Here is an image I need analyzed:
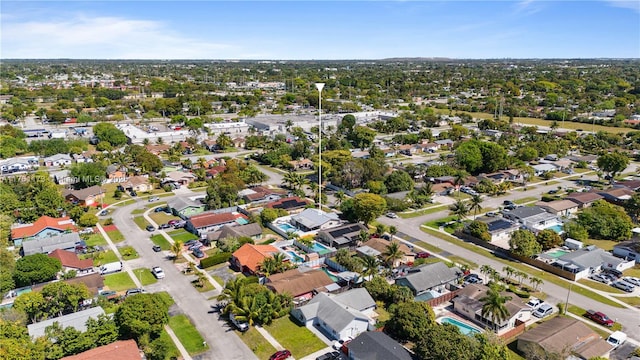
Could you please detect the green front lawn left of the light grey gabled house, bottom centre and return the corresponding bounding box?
[264,316,327,359]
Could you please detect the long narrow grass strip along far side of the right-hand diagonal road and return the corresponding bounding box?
[420,226,623,308]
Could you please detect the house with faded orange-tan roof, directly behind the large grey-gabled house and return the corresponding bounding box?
[265,267,339,301]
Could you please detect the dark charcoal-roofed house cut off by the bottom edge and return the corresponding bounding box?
[346,331,413,360]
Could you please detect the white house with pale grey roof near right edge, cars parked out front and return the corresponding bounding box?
[552,245,635,279]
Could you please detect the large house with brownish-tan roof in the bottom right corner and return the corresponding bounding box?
[517,316,613,360]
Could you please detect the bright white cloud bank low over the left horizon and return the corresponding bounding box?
[1,15,244,59]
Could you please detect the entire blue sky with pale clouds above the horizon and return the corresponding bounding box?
[0,0,640,60]
